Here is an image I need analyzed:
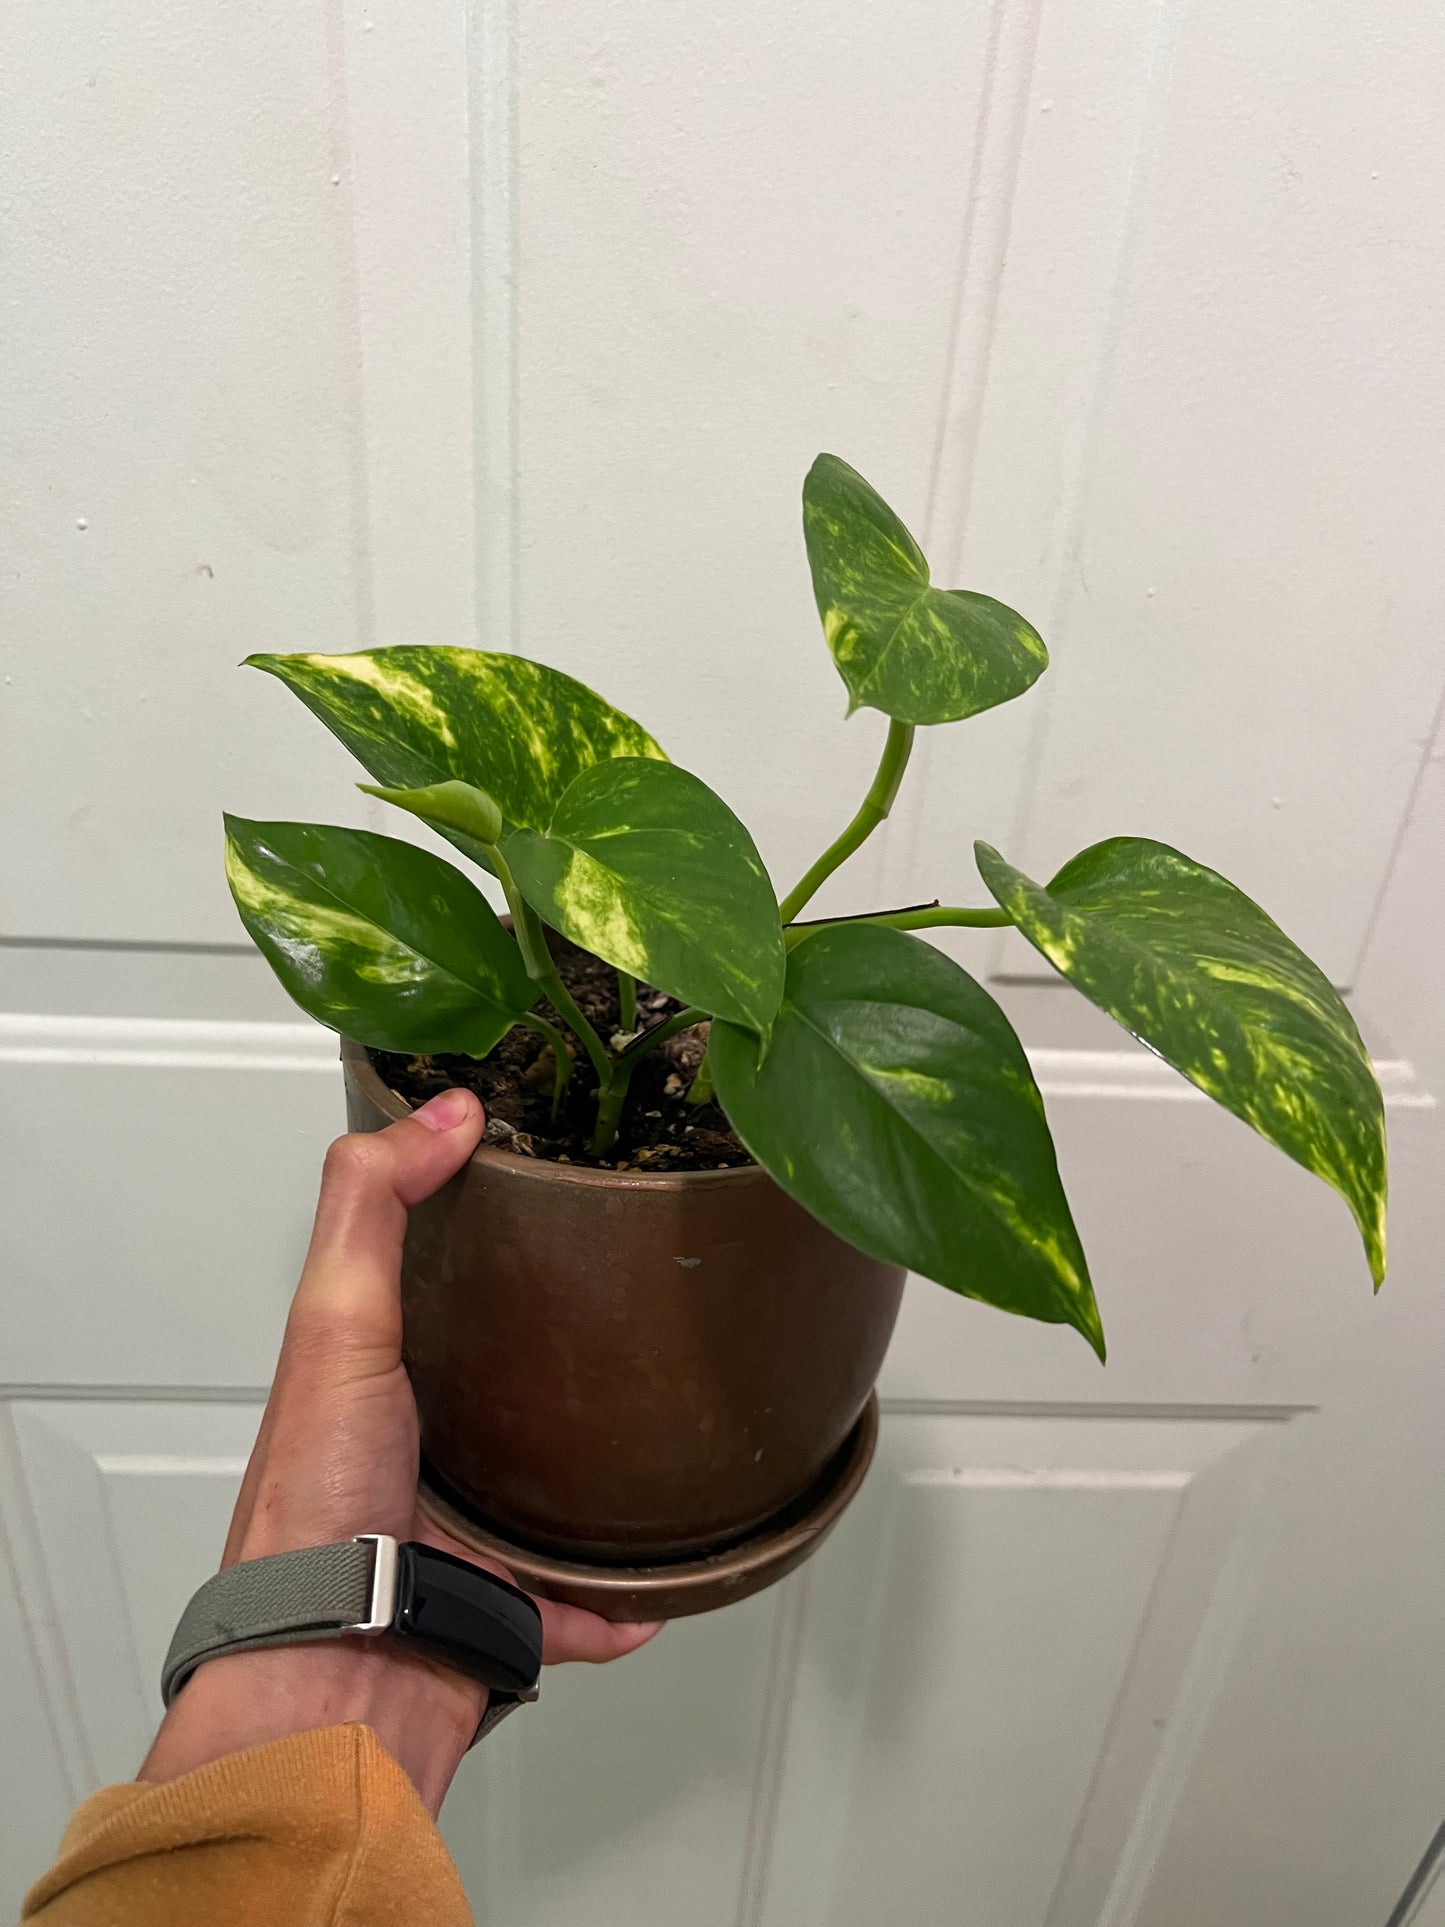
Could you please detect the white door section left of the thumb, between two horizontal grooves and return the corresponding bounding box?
[0,1012,345,1386]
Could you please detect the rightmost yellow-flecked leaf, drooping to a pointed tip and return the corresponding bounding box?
[977,836,1387,1285]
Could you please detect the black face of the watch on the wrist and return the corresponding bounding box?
[393,1545,541,1692]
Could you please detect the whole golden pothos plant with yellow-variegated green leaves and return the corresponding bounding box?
[225,455,1385,1359]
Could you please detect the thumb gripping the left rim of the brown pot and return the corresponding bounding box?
[283,1091,486,1368]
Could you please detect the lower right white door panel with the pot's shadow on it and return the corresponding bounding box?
[761,1414,1279,1927]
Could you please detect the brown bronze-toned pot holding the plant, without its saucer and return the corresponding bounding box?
[341,1039,904,1565]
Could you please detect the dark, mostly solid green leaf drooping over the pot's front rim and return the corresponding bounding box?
[711,923,1104,1359]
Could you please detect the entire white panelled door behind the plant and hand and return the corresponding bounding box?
[0,0,1445,1927]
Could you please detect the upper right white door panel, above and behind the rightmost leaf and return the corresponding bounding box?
[965,0,1445,983]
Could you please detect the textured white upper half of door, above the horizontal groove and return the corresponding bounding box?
[2,0,1445,963]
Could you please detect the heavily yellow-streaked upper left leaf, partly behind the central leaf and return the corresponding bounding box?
[247,644,663,856]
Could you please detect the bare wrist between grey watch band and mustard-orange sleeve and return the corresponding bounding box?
[139,1636,487,1815]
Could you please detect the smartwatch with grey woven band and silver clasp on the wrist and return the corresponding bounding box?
[160,1532,541,1746]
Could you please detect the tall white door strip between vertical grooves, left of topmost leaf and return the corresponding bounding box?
[516,0,1025,906]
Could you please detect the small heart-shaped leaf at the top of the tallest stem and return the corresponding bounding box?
[803,455,1048,723]
